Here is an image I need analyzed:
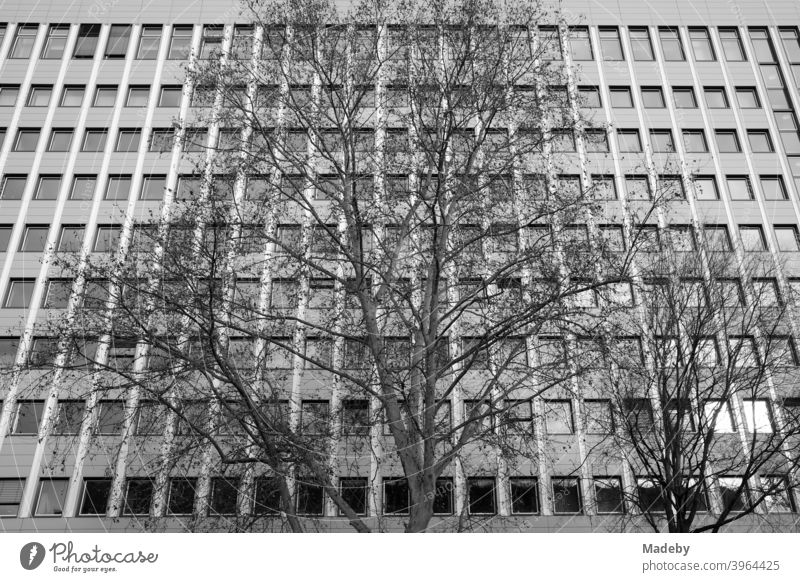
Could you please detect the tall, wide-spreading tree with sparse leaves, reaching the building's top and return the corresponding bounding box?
[36,0,648,531]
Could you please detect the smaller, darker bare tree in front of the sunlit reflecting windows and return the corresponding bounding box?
[587,231,800,532]
